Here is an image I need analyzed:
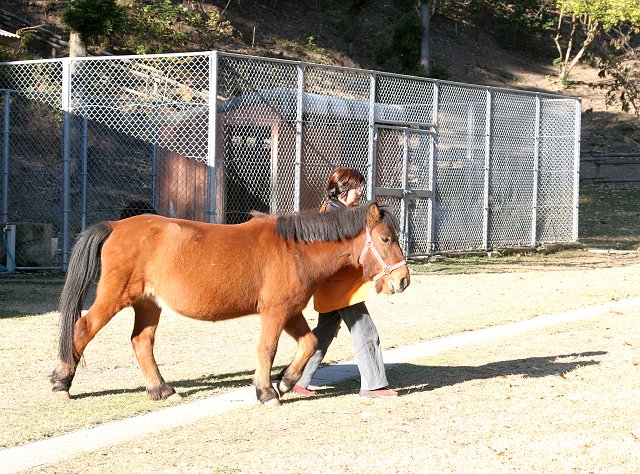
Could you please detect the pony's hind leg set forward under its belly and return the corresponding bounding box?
[131,300,176,400]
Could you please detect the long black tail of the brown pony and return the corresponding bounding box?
[58,222,113,364]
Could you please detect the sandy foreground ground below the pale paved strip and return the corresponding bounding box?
[23,266,640,473]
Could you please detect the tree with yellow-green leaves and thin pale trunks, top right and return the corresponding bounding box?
[554,0,640,81]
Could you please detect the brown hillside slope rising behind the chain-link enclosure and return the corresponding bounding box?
[2,0,640,155]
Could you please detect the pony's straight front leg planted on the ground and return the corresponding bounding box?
[253,312,283,405]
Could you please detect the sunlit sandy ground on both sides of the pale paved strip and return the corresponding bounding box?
[0,252,640,472]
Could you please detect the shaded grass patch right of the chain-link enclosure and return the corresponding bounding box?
[578,183,640,250]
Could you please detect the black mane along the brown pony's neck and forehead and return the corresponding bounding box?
[276,203,398,243]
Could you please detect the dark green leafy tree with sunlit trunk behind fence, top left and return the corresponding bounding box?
[62,0,121,56]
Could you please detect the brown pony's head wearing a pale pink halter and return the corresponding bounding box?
[358,202,411,294]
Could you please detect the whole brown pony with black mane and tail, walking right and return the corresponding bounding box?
[51,202,409,404]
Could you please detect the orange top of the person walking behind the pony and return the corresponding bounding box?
[313,199,371,313]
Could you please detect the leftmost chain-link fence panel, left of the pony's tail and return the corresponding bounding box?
[0,61,63,269]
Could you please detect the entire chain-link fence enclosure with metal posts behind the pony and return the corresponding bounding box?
[0,51,580,269]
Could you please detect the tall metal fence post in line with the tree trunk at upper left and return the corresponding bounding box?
[62,58,71,272]
